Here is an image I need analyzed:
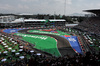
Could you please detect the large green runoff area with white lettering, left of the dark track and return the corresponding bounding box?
[15,33,61,57]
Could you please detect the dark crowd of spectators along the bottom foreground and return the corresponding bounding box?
[0,52,100,66]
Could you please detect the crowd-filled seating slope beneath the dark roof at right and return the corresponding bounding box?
[75,17,100,34]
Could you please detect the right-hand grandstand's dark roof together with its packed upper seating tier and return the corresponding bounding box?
[74,10,100,36]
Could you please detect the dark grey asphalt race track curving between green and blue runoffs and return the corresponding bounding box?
[18,29,76,56]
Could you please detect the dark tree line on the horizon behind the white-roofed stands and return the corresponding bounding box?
[0,14,86,23]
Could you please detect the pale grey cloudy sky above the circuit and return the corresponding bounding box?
[0,0,100,15]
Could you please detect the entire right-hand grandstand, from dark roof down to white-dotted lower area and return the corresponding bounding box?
[73,9,100,55]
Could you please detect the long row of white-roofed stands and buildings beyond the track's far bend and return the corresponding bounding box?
[0,16,66,28]
